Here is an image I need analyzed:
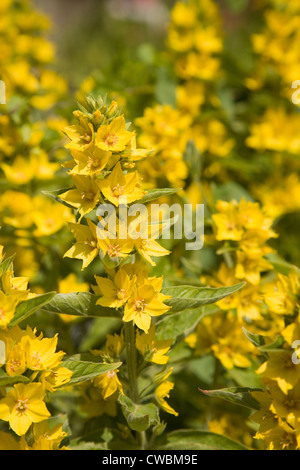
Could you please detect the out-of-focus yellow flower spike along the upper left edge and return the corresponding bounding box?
[0,0,72,276]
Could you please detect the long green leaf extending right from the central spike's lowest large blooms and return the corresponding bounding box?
[162,282,245,313]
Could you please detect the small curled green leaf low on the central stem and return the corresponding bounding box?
[118,394,159,432]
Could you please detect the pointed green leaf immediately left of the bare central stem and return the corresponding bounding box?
[62,354,122,385]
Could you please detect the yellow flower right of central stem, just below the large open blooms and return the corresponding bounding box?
[136,325,173,364]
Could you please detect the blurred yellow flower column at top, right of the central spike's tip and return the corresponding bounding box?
[135,0,234,191]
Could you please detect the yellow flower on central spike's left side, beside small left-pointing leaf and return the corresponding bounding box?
[59,175,100,221]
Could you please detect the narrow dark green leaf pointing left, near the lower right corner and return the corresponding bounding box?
[199,387,262,410]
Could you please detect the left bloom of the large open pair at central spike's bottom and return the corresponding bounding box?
[95,268,135,308]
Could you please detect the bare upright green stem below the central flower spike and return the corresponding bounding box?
[125,321,139,403]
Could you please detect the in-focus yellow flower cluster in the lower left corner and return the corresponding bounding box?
[0,247,72,450]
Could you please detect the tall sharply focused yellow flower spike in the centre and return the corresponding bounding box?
[59,96,176,422]
